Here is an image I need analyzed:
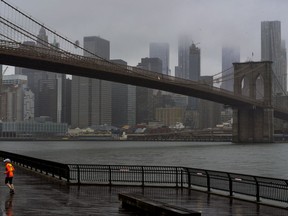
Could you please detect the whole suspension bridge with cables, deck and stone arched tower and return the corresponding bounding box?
[0,0,288,143]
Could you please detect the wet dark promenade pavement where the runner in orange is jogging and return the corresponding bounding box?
[0,166,288,216]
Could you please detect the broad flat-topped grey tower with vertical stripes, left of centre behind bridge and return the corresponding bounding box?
[71,36,112,128]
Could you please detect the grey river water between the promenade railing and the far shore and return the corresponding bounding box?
[0,141,288,179]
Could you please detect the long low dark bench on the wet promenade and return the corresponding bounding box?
[118,193,201,216]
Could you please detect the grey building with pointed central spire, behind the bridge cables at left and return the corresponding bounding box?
[15,27,65,123]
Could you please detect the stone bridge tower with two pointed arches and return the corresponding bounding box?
[232,61,274,143]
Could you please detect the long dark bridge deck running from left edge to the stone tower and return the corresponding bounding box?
[0,40,288,120]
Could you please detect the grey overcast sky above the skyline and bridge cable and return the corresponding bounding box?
[6,0,288,75]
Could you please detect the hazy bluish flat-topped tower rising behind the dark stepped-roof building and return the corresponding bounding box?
[149,43,170,75]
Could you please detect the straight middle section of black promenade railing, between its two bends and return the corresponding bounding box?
[68,164,184,188]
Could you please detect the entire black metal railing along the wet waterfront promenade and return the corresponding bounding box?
[0,151,288,203]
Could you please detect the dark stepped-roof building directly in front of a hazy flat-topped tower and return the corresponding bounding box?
[136,58,162,123]
